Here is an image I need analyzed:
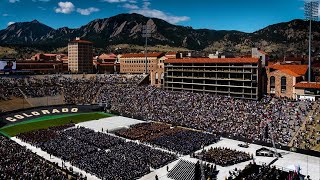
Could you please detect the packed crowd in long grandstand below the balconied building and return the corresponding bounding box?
[98,85,312,145]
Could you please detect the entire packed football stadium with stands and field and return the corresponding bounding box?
[0,74,320,180]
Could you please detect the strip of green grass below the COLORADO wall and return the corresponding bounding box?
[0,112,113,137]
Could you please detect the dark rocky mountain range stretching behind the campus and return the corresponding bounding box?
[0,14,320,55]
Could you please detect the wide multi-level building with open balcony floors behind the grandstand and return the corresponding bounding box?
[164,58,261,100]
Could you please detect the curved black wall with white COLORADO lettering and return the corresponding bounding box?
[0,105,101,128]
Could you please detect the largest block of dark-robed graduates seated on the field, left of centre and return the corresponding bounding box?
[19,127,176,179]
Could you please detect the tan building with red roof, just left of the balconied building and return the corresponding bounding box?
[119,53,165,87]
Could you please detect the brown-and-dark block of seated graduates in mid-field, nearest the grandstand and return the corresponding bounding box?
[116,123,219,155]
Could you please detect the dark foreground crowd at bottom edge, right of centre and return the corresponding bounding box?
[228,162,303,180]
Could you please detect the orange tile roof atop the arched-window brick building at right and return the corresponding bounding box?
[268,64,308,77]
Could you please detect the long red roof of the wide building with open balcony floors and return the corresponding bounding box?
[164,58,259,63]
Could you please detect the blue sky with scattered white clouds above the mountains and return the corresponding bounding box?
[0,0,312,32]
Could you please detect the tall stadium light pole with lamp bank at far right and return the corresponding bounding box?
[304,0,319,82]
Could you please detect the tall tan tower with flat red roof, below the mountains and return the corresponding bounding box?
[68,38,93,73]
